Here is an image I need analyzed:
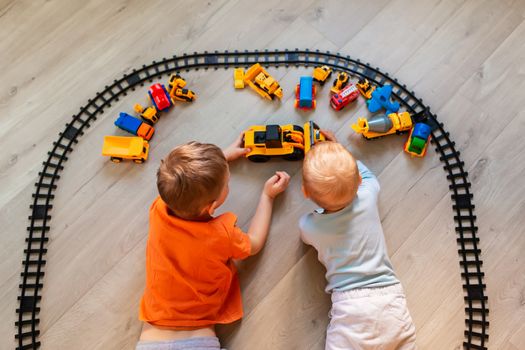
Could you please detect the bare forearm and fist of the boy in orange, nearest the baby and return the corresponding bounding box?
[248,171,290,255]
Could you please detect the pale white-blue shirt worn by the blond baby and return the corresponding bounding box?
[299,161,399,293]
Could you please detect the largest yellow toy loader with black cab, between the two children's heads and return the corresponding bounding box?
[244,122,325,163]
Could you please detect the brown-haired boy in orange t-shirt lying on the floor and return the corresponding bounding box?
[136,135,290,350]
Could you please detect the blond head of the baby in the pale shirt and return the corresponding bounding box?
[303,141,361,211]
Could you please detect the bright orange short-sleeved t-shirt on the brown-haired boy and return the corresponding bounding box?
[139,197,251,327]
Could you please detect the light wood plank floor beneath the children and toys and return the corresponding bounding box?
[0,0,525,350]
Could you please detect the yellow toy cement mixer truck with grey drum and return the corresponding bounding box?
[352,112,412,140]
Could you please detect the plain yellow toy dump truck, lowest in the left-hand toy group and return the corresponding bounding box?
[102,136,149,164]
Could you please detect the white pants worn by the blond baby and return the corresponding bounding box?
[325,283,417,350]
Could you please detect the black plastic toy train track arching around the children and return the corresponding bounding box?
[15,49,489,350]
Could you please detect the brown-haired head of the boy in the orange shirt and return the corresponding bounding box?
[157,142,230,220]
